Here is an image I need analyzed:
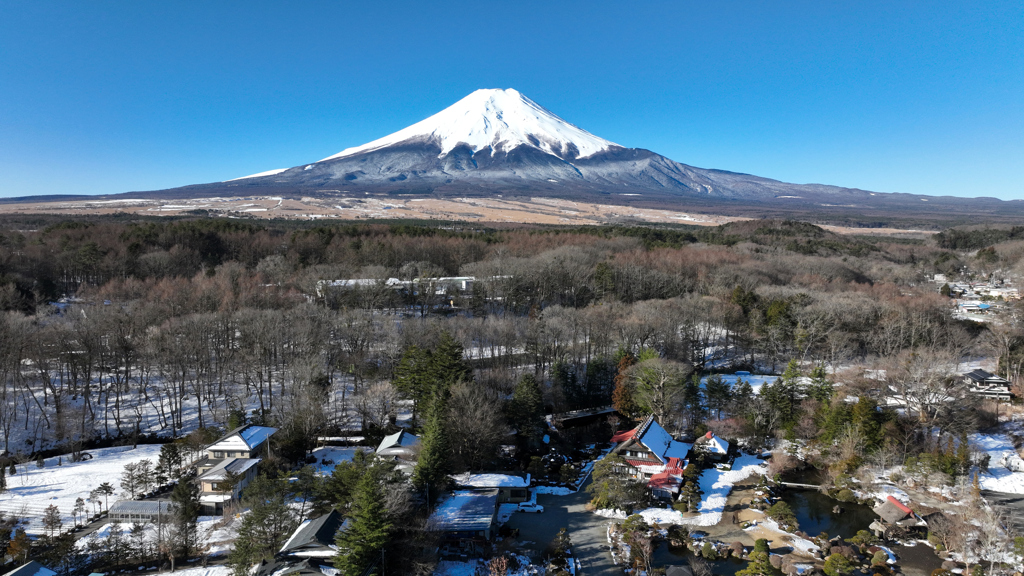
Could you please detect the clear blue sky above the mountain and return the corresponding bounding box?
[0,0,1024,199]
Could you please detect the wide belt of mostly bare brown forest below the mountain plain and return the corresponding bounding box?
[0,218,1020,454]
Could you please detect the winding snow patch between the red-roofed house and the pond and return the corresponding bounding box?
[597,454,767,526]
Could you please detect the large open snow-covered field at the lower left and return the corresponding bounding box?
[0,444,162,534]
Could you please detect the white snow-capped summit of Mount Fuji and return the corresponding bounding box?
[321,88,622,162]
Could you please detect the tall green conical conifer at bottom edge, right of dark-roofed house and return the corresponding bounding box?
[334,463,391,576]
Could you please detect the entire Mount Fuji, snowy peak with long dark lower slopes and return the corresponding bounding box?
[117,89,1020,214]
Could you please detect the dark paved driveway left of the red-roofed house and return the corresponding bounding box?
[506,482,623,576]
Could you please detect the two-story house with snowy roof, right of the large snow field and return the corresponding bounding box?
[196,424,278,516]
